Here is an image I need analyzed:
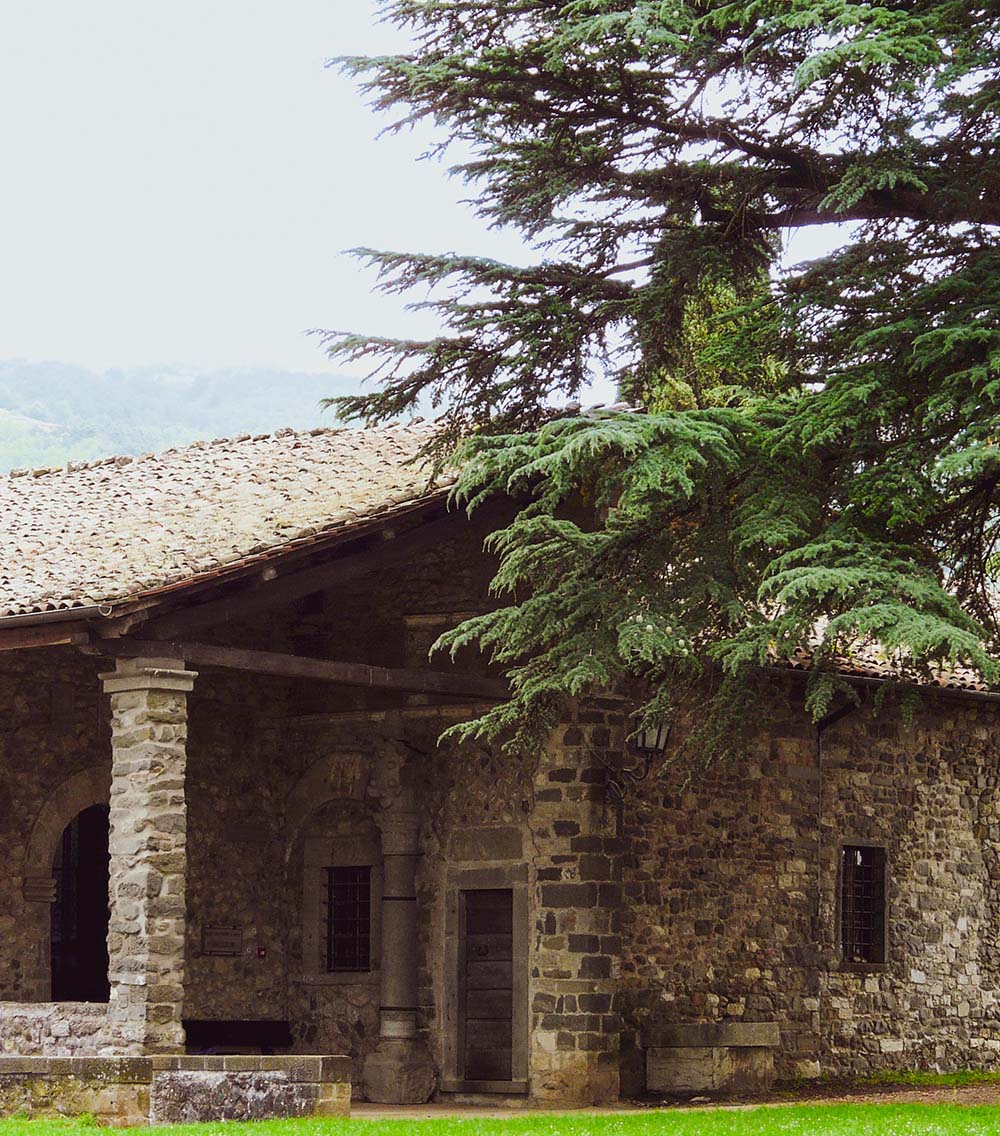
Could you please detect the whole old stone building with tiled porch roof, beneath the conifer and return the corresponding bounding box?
[0,426,1000,1104]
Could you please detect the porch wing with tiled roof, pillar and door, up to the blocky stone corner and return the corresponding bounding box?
[0,427,623,1102]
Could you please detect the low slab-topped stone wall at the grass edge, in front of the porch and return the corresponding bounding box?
[0,1054,351,1125]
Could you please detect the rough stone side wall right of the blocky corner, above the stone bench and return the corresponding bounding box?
[619,687,1000,1093]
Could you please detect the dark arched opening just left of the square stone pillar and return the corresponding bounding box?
[51,804,109,1002]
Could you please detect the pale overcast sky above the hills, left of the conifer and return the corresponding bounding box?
[0,0,531,370]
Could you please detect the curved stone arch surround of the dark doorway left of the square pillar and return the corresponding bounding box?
[23,762,111,1002]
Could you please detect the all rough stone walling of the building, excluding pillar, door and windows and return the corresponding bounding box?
[0,511,1000,1101]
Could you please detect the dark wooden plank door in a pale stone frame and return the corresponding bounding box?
[459,888,514,1080]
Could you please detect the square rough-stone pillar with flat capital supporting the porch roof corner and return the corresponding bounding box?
[101,659,197,1055]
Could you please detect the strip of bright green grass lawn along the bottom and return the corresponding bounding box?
[0,1104,1000,1136]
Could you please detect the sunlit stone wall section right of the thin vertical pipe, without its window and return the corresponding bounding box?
[819,700,1000,1072]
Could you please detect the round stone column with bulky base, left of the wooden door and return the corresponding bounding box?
[364,810,435,1104]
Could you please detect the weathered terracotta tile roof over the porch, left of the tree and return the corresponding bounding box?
[0,423,449,616]
